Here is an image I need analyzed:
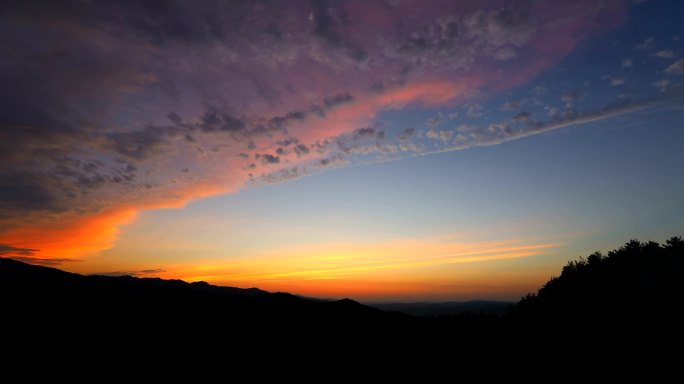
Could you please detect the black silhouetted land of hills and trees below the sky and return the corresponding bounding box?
[0,237,684,383]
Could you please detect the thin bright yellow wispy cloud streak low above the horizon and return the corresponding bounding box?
[175,238,559,284]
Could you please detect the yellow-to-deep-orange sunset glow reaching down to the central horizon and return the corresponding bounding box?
[164,239,560,300]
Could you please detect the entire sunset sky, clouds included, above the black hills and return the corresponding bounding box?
[0,0,684,302]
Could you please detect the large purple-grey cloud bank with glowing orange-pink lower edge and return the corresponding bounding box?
[0,0,632,259]
